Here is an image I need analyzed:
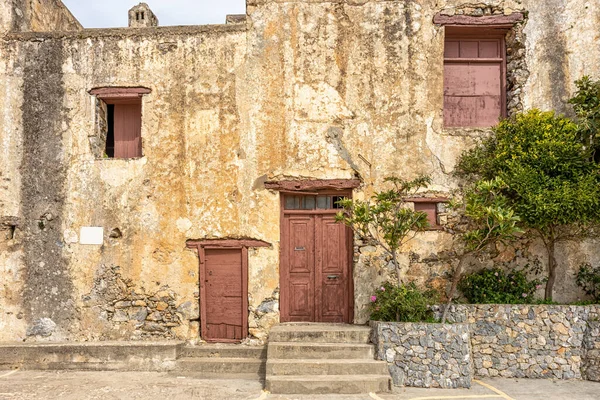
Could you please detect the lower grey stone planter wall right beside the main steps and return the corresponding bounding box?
[371,321,473,388]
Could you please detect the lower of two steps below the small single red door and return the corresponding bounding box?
[176,357,266,376]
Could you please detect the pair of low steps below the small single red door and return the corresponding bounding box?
[176,344,266,379]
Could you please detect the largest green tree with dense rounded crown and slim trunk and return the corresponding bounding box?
[457,110,600,300]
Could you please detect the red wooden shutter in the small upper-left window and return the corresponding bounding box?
[114,102,142,158]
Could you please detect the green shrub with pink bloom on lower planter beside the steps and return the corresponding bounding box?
[369,283,439,322]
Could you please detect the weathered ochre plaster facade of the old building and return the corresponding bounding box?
[0,0,600,341]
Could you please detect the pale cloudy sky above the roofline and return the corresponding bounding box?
[62,0,246,28]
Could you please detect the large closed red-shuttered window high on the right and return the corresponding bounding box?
[444,27,506,127]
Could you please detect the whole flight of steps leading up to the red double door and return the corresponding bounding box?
[265,323,391,395]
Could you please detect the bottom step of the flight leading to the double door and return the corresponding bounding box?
[265,374,391,394]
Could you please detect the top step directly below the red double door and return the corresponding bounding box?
[269,323,371,343]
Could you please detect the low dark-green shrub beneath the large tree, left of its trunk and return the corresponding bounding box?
[458,268,541,304]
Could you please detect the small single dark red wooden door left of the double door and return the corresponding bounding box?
[200,249,245,341]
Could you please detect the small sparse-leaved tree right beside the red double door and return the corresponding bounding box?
[336,177,430,287]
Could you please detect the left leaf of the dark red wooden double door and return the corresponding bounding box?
[281,215,315,322]
